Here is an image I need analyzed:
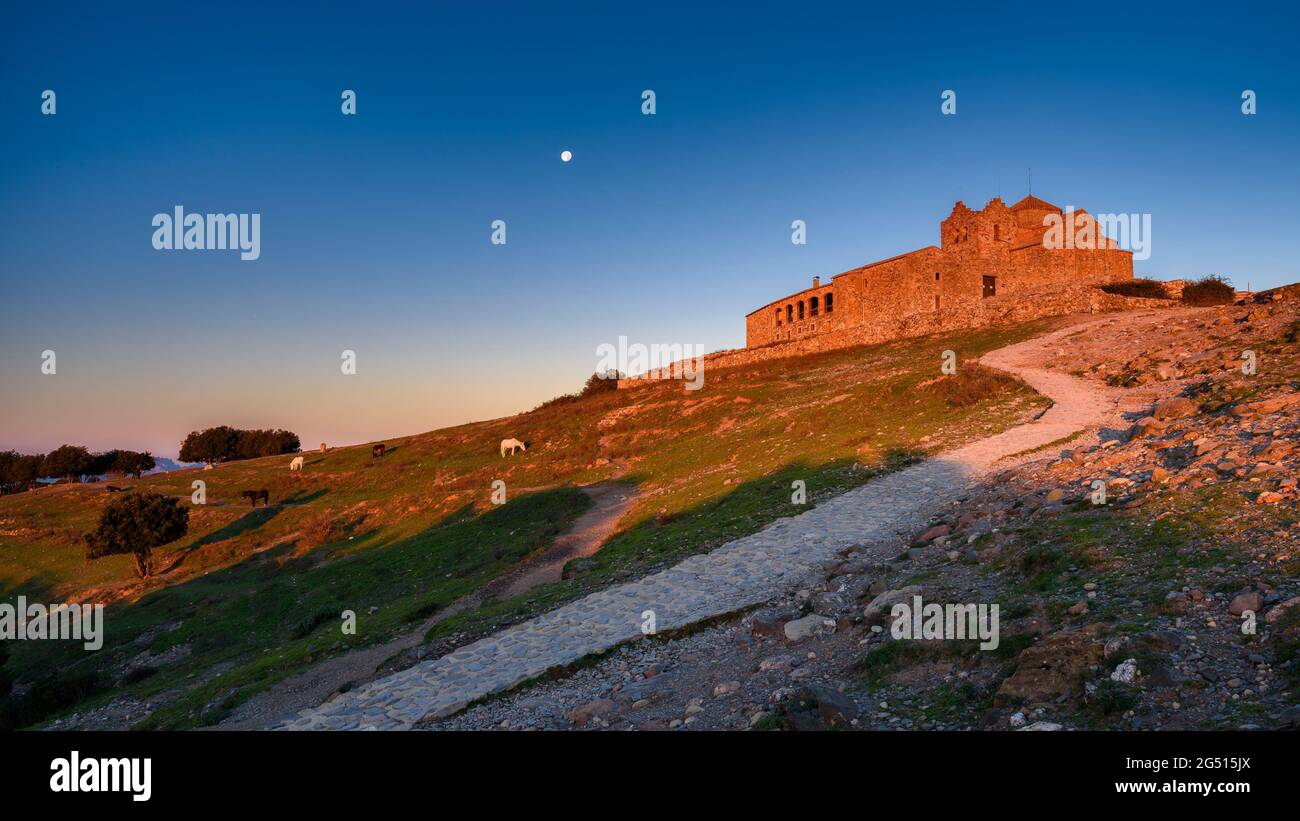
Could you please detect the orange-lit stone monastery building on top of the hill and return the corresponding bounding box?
[745,195,1134,348]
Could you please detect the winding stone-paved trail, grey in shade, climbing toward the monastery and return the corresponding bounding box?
[276,315,1123,730]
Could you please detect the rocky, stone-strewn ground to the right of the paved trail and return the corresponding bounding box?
[420,288,1300,730]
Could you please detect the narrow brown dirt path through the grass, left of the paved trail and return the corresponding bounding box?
[209,482,634,730]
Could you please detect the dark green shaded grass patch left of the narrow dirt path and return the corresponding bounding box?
[9,488,592,727]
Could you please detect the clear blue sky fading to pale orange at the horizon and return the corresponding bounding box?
[0,3,1300,455]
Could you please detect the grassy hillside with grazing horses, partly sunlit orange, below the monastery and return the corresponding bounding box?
[0,316,1043,726]
